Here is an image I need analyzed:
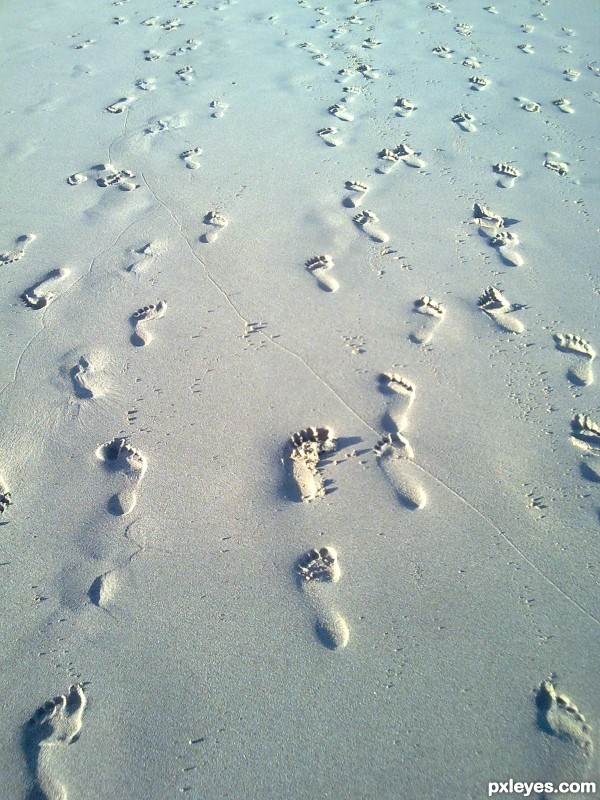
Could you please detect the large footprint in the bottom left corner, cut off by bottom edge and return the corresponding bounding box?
[22,683,87,800]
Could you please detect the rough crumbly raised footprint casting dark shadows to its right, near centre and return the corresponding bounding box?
[286,427,336,501]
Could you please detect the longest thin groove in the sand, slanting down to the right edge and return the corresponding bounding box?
[140,173,600,625]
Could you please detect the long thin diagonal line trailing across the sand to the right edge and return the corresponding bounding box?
[138,173,600,627]
